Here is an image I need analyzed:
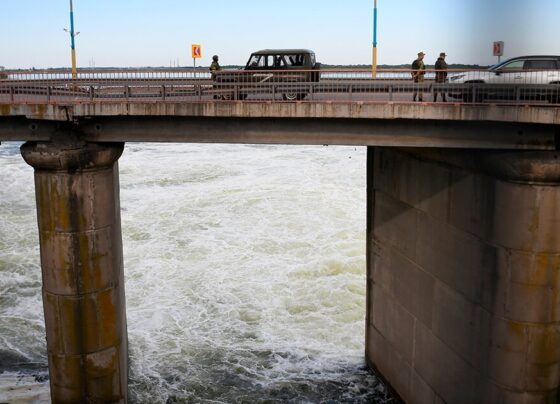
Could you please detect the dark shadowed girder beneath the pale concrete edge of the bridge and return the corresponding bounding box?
[0,115,560,150]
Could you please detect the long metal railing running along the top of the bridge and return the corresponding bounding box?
[0,69,560,106]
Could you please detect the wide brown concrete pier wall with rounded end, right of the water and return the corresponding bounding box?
[366,148,560,404]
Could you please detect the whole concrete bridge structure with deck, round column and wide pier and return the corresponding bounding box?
[0,68,560,404]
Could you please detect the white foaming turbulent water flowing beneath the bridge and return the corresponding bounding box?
[0,143,392,403]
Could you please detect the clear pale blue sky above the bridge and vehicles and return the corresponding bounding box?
[0,0,560,69]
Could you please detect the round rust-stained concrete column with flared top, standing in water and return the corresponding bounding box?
[21,143,127,403]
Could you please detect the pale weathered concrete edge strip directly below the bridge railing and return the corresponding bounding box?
[0,101,560,125]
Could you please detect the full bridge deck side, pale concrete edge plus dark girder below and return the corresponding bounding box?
[0,101,560,150]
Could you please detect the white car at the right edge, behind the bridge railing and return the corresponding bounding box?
[449,56,560,104]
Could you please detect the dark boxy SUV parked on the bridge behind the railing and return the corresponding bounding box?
[215,49,321,101]
